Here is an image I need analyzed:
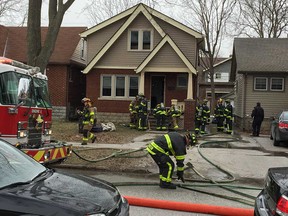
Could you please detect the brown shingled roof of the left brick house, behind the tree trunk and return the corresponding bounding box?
[0,26,86,64]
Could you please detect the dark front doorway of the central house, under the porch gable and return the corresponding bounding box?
[151,76,165,109]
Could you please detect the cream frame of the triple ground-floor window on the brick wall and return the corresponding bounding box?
[100,74,139,100]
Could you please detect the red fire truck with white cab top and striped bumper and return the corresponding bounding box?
[0,57,72,163]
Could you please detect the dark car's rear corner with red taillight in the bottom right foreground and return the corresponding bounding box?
[254,167,288,216]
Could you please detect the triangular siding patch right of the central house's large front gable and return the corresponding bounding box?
[155,17,197,64]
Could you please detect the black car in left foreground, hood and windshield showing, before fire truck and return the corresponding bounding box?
[0,139,129,216]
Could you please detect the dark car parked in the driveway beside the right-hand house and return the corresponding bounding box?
[270,111,288,146]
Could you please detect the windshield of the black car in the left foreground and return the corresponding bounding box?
[0,140,46,188]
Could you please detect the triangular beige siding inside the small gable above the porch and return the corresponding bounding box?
[147,43,188,70]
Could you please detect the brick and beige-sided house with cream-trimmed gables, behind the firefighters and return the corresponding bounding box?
[80,3,204,128]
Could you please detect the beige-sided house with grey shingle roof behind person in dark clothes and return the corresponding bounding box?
[231,38,288,131]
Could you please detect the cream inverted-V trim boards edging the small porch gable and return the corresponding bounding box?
[136,35,197,74]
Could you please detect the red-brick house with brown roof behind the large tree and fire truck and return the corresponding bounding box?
[0,25,87,118]
